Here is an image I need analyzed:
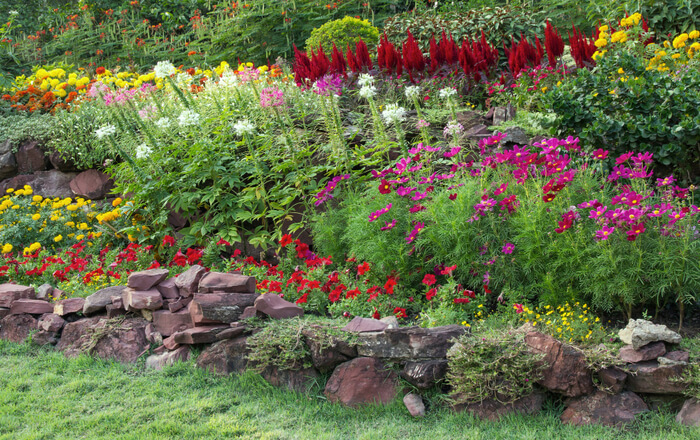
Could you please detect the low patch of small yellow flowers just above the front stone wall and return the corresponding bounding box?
[520,302,606,343]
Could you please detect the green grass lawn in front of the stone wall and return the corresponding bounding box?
[0,341,700,440]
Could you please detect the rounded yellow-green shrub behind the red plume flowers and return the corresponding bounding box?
[306,17,379,56]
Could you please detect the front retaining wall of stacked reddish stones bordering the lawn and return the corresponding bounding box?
[0,266,700,426]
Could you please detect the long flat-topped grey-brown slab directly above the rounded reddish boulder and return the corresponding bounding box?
[357,325,467,361]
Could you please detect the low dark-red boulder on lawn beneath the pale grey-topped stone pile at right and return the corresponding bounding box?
[561,390,649,426]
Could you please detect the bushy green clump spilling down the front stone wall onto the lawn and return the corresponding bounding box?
[447,328,546,403]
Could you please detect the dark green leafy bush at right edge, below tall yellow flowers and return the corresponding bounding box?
[544,52,700,182]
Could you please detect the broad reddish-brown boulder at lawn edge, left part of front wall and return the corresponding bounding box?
[57,316,150,362]
